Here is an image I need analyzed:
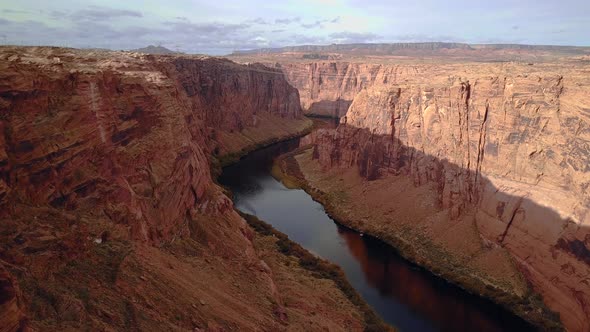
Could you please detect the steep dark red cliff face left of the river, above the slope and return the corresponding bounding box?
[0,47,301,243]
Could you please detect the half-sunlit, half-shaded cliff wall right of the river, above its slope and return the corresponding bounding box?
[301,63,590,331]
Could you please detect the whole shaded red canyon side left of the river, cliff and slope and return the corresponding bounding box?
[0,47,380,331]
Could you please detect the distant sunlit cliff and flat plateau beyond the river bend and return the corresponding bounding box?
[231,43,590,117]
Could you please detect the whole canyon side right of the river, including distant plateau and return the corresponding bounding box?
[232,46,590,331]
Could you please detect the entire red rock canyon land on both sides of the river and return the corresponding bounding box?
[0,43,590,331]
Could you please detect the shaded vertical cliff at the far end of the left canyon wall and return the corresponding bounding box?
[170,58,301,132]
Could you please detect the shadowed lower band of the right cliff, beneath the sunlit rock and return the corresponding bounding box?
[312,124,590,330]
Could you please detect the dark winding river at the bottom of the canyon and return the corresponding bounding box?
[219,135,532,332]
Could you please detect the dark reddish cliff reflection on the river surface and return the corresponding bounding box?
[338,227,534,332]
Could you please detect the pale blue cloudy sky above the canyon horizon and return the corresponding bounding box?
[0,0,590,55]
